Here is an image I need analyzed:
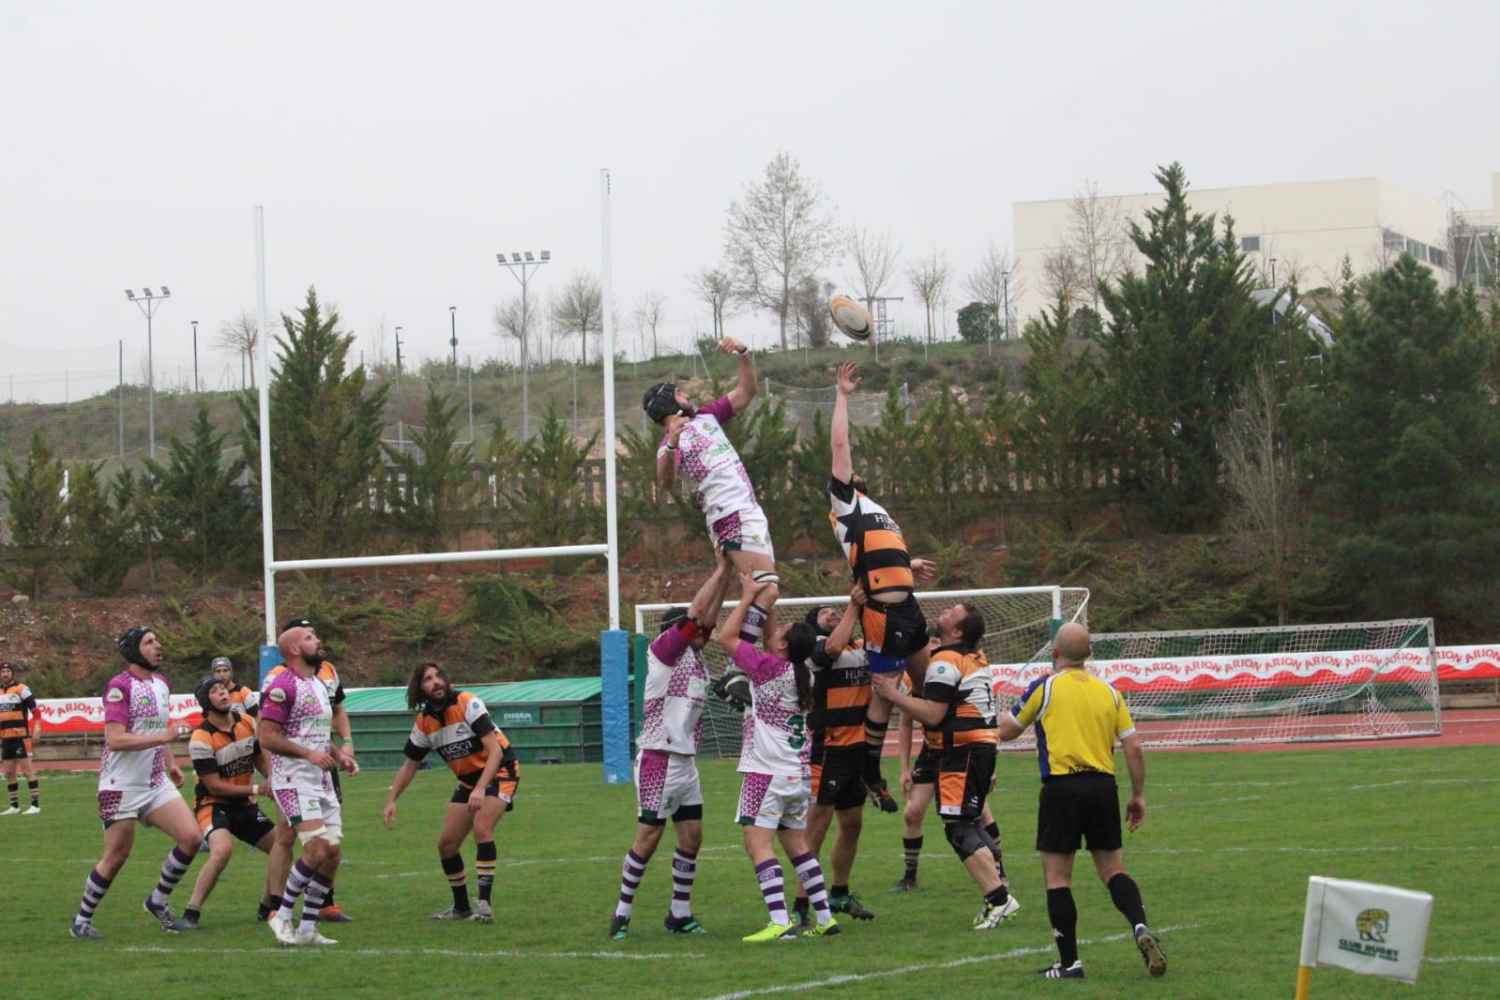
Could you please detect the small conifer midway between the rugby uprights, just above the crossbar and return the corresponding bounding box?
[384,384,479,552]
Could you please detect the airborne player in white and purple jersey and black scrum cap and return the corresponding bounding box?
[641,337,777,643]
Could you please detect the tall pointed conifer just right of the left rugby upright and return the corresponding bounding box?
[240,288,389,556]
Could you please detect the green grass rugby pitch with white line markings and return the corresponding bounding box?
[14,747,1500,1000]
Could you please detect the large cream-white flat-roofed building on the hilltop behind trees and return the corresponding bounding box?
[1013,174,1500,321]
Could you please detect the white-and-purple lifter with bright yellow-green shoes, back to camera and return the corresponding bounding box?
[719,573,839,943]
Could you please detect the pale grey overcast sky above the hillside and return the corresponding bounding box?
[0,0,1500,400]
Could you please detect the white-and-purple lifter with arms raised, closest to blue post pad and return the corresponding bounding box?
[609,556,732,942]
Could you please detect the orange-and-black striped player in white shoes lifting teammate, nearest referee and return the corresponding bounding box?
[872,604,1020,930]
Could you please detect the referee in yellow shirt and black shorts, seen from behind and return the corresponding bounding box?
[1001,624,1167,979]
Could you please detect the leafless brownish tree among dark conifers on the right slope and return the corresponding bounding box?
[1220,364,1302,625]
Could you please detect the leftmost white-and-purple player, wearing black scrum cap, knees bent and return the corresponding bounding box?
[72,625,203,940]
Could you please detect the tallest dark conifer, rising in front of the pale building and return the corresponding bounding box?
[1098,163,1271,529]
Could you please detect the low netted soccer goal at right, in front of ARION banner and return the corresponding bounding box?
[1032,618,1443,745]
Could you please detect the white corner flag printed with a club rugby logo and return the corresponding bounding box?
[1301,876,1433,982]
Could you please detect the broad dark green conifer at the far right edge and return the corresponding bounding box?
[1301,255,1500,622]
